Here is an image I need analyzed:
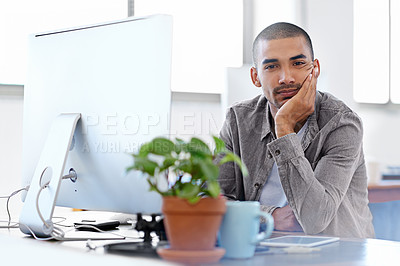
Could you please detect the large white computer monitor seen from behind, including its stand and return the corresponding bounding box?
[20,15,172,235]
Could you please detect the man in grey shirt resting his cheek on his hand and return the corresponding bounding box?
[219,23,374,238]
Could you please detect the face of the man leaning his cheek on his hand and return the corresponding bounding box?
[251,36,319,115]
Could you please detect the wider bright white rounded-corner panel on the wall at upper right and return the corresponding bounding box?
[353,0,392,104]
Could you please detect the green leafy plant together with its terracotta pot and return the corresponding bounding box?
[127,136,247,260]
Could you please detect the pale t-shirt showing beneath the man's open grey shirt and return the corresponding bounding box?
[260,120,308,207]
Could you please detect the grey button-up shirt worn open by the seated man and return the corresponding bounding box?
[219,91,374,238]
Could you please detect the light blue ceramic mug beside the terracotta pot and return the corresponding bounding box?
[219,201,274,259]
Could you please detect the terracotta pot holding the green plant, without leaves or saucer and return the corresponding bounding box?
[162,197,226,250]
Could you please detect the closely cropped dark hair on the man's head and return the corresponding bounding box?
[253,22,314,67]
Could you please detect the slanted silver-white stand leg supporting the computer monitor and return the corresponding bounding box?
[19,113,81,237]
